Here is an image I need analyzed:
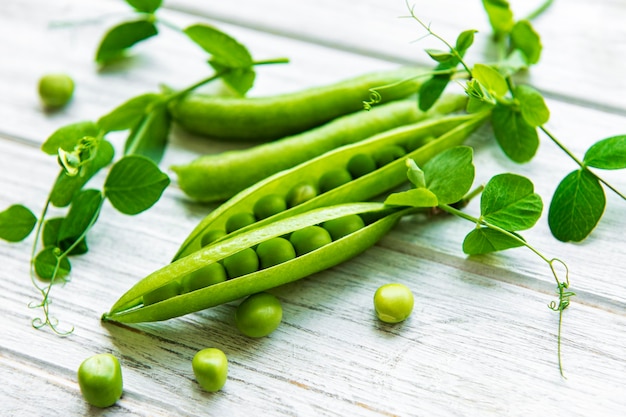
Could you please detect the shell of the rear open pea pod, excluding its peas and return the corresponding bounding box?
[174,109,487,259]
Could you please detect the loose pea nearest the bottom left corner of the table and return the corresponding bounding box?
[78,353,123,408]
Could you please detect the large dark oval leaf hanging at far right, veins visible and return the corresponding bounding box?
[548,169,606,242]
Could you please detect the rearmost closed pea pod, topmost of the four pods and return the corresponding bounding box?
[171,67,427,142]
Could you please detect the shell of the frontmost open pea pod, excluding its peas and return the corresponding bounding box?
[102,203,414,323]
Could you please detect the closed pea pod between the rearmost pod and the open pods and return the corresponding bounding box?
[172,95,467,202]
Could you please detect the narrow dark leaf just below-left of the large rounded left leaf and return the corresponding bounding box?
[57,190,103,250]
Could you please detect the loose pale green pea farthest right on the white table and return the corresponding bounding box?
[374,283,414,323]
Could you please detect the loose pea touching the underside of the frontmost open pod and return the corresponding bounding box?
[235,292,283,338]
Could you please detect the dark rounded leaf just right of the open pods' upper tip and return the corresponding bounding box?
[491,105,539,163]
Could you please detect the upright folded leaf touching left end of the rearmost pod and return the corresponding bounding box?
[124,101,172,164]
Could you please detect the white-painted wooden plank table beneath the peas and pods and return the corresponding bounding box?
[0,0,626,417]
